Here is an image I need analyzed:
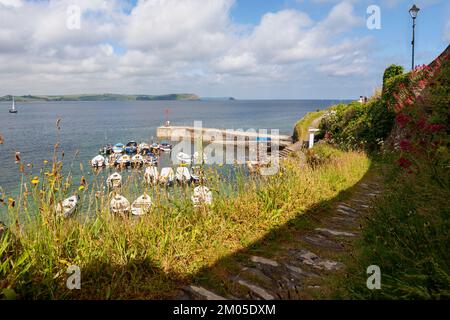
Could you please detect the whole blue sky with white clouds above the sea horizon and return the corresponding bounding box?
[0,0,450,99]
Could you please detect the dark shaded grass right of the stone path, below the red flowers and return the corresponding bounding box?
[334,155,450,299]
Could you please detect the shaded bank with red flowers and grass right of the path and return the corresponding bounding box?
[327,49,450,299]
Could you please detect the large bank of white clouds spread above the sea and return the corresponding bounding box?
[0,0,384,95]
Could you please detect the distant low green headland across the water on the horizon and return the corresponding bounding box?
[0,93,200,102]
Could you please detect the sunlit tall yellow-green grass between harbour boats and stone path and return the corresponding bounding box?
[0,146,369,299]
